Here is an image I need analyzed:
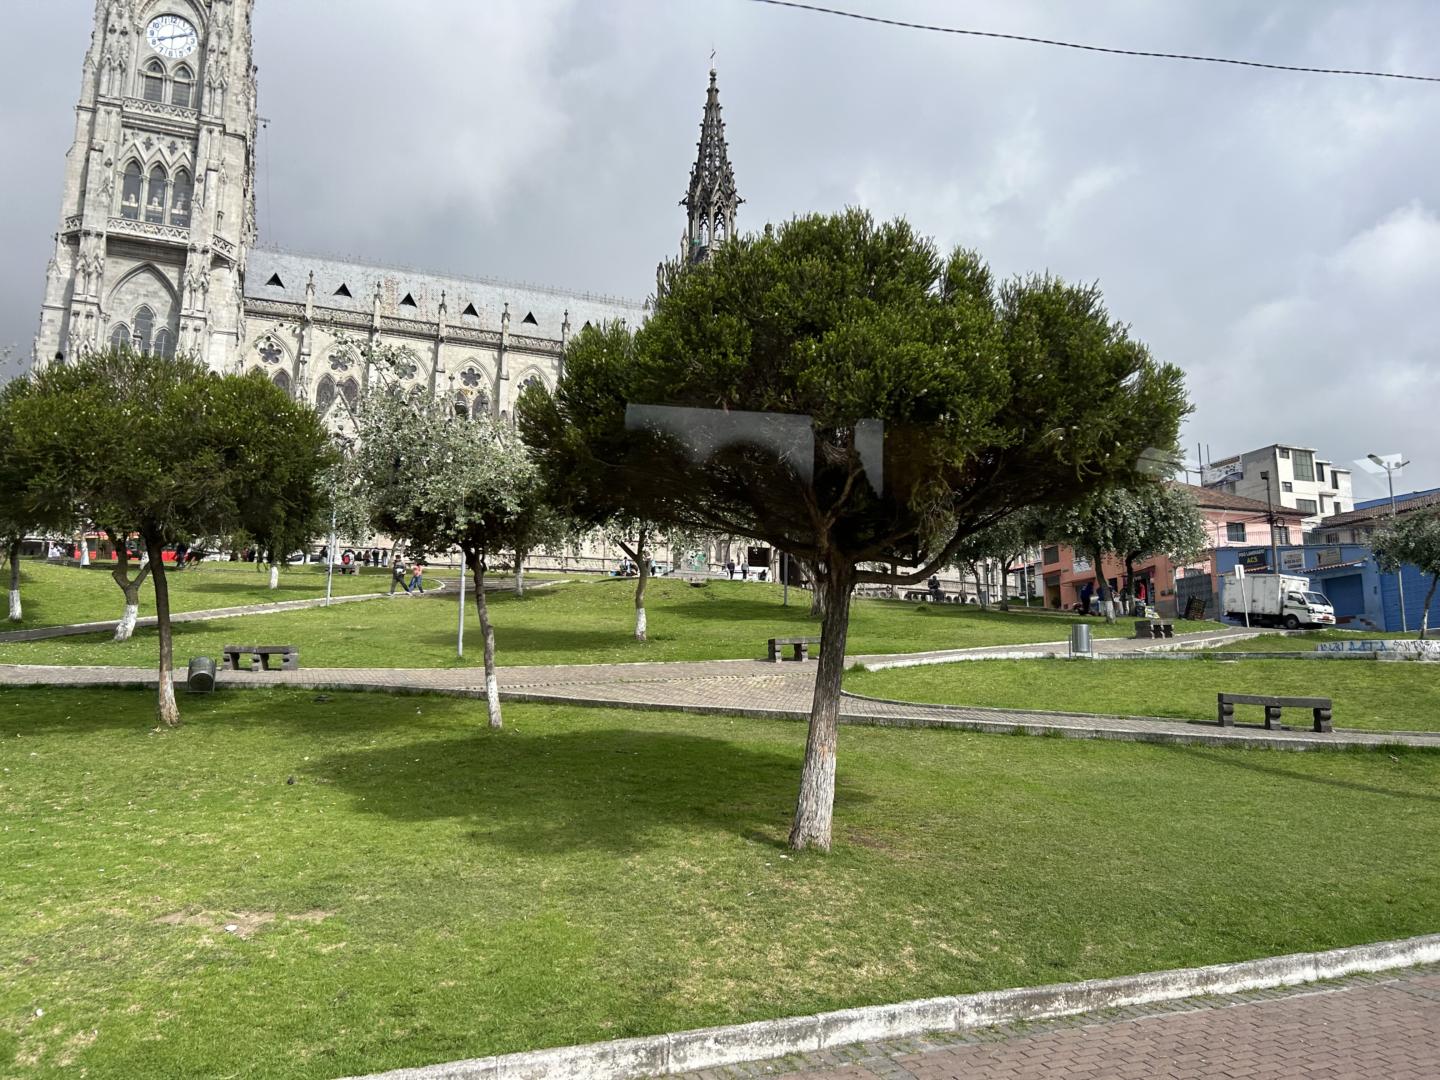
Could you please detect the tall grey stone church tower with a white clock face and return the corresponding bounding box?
[33,0,256,370]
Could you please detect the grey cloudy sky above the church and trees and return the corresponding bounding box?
[0,0,1440,497]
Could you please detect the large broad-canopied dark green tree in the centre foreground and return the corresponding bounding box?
[523,210,1188,850]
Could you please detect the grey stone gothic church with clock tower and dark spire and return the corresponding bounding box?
[33,0,742,426]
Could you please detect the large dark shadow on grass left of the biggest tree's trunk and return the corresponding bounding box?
[312,727,871,855]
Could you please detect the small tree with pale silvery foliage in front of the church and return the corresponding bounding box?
[354,377,539,727]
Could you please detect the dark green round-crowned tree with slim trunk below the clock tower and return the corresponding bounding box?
[14,348,328,726]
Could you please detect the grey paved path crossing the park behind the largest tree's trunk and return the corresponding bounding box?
[0,642,1440,750]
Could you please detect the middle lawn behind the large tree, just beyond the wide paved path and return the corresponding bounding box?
[0,572,1212,667]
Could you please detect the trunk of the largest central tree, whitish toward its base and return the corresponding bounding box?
[791,563,855,851]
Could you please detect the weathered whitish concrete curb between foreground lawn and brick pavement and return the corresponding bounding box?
[339,935,1440,1080]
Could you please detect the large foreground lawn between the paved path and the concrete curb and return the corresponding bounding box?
[0,688,1440,1080]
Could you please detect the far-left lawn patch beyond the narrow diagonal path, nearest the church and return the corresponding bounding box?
[0,559,390,631]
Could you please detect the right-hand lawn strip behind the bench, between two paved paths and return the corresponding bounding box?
[845,658,1440,732]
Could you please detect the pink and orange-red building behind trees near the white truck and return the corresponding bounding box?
[1041,484,1305,616]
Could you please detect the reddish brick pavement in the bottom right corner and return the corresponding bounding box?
[671,966,1440,1080]
